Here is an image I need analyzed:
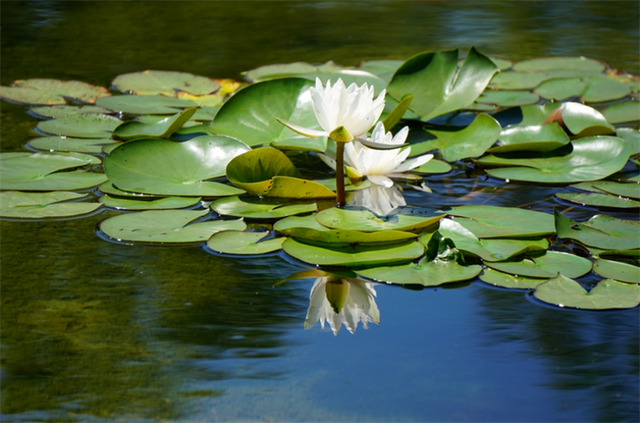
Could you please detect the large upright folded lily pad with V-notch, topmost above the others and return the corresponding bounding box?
[387,47,498,122]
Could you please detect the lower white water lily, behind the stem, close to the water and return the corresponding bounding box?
[320,122,433,188]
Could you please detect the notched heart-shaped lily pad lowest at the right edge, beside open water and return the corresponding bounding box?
[533,275,640,310]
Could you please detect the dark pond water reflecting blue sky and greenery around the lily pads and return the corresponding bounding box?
[0,0,640,422]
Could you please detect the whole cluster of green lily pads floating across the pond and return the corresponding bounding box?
[0,48,640,314]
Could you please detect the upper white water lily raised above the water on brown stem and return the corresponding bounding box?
[278,78,386,142]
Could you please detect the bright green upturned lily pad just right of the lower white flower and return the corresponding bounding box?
[410,113,501,162]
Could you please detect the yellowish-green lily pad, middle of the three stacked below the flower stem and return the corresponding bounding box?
[273,215,417,246]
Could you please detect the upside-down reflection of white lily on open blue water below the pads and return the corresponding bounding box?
[304,275,380,335]
